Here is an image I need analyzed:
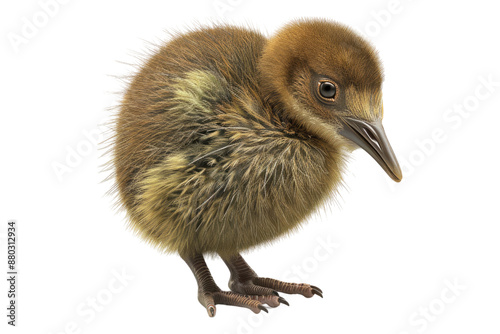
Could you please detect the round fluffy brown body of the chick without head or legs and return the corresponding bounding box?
[114,26,338,252]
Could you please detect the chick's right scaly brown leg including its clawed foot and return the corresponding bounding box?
[221,254,323,300]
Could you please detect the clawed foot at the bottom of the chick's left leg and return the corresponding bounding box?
[198,291,288,317]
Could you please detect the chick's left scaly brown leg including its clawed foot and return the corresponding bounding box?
[182,254,267,317]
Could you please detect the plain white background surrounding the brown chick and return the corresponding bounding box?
[0,0,500,334]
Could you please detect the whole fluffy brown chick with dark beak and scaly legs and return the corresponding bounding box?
[111,20,402,316]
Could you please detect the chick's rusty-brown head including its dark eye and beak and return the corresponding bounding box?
[259,20,402,182]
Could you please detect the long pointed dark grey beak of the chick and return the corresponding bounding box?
[340,118,403,182]
